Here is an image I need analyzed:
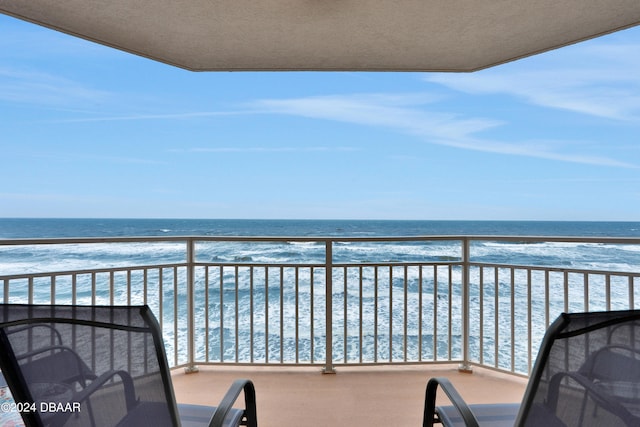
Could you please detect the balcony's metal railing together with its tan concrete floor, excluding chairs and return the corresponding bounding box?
[0,236,640,426]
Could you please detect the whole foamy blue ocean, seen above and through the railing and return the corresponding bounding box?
[0,219,640,371]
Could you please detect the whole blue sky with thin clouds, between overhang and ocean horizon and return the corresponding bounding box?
[0,15,640,221]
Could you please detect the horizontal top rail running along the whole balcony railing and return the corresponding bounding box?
[0,235,640,246]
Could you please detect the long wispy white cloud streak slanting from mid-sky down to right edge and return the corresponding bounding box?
[248,94,636,168]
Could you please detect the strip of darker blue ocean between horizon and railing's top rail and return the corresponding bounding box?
[0,218,640,239]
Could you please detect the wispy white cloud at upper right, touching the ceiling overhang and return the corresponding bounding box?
[424,41,640,121]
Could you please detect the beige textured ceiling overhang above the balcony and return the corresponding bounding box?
[0,0,640,72]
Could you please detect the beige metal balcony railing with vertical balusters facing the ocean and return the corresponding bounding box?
[0,236,640,375]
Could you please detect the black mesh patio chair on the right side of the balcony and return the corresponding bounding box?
[423,310,640,427]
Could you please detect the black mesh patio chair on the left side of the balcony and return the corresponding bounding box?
[0,304,257,427]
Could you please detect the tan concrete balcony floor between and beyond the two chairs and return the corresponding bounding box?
[172,365,527,427]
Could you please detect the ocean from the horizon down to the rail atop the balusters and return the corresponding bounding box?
[0,218,640,276]
